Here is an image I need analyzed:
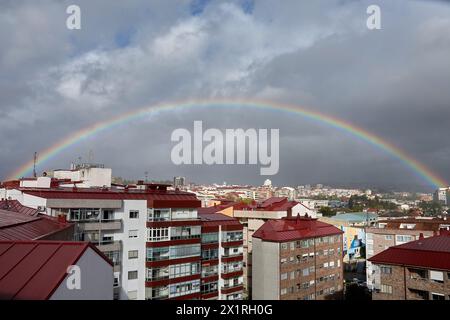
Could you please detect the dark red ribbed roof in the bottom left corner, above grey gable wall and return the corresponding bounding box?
[0,241,112,300]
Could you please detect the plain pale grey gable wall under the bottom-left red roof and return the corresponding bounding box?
[50,248,113,300]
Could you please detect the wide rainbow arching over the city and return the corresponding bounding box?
[8,99,448,188]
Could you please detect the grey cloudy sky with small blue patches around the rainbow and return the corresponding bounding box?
[0,0,450,190]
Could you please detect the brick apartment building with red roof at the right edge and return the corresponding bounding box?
[369,230,450,300]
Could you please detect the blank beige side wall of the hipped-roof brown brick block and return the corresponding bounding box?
[252,238,280,300]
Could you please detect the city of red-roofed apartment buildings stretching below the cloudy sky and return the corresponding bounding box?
[0,163,450,300]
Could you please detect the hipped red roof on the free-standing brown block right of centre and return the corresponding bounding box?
[253,217,343,242]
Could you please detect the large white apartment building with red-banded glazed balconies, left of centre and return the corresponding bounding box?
[0,178,201,299]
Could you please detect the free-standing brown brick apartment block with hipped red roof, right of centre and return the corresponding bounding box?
[252,216,343,300]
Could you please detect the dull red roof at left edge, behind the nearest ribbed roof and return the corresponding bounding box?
[0,210,72,240]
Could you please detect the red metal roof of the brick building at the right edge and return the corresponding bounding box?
[368,232,450,270]
